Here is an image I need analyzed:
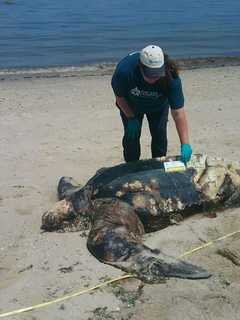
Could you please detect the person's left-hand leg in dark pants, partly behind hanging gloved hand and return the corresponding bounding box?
[120,111,143,162]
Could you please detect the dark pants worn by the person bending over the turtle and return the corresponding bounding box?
[120,108,168,162]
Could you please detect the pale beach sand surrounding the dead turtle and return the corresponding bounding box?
[0,66,240,320]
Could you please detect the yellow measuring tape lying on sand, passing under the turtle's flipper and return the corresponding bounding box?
[0,230,240,318]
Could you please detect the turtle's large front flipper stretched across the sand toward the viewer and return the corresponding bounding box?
[87,199,210,283]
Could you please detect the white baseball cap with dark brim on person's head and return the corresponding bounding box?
[140,45,165,77]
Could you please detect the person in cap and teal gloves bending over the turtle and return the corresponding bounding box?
[111,45,192,163]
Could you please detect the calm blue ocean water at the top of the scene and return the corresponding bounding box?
[0,0,240,68]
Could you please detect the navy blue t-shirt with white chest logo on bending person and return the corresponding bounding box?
[111,52,184,113]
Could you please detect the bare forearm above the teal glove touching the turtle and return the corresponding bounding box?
[171,107,189,144]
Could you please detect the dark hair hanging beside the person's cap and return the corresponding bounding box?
[158,53,179,95]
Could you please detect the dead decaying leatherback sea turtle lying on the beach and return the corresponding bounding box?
[42,155,240,282]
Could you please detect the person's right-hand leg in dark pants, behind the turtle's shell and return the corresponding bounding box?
[146,108,169,158]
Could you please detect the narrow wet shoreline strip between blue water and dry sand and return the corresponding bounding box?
[0,56,240,81]
